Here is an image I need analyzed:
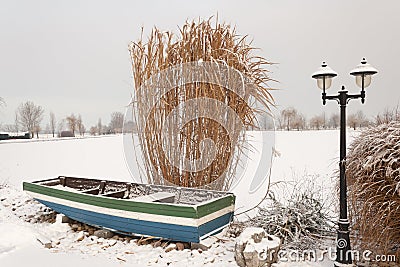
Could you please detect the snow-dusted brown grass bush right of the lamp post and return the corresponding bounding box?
[346,122,400,258]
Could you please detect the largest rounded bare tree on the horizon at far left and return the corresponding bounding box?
[17,101,44,137]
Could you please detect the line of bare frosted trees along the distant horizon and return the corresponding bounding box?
[0,97,400,138]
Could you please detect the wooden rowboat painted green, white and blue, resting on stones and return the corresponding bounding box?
[23,176,235,243]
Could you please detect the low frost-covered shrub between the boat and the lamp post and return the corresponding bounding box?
[248,176,335,249]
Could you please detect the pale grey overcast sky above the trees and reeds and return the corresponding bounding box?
[0,0,400,128]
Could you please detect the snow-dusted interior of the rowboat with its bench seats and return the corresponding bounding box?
[35,176,232,205]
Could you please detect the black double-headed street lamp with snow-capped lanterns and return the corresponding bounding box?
[312,58,378,267]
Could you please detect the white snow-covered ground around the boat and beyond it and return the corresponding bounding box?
[0,131,354,267]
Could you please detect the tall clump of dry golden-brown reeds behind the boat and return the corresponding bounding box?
[129,18,273,190]
